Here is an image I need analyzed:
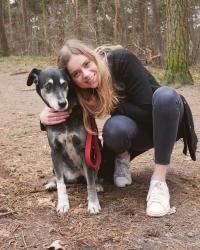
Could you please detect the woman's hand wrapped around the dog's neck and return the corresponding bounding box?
[40,106,72,125]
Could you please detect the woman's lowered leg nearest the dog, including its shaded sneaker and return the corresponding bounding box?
[103,115,153,187]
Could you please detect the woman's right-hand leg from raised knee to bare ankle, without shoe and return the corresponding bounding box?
[152,87,184,180]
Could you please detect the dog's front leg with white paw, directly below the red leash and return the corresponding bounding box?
[83,161,101,214]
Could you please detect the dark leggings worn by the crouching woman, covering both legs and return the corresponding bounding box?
[103,87,184,165]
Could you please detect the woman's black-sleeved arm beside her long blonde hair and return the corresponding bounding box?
[108,49,159,122]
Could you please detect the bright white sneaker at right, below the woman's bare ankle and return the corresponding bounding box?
[146,180,170,217]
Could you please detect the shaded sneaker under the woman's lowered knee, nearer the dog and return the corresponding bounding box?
[113,155,132,187]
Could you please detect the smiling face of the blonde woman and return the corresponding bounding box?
[67,55,98,89]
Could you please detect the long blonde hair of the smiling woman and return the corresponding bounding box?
[58,39,119,132]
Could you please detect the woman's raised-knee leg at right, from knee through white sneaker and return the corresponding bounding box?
[147,87,184,217]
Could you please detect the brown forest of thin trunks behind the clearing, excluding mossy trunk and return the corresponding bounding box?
[0,0,200,69]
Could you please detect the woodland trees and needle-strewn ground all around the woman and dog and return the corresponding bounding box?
[0,0,200,250]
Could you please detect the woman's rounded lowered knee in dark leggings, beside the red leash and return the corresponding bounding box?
[103,115,137,152]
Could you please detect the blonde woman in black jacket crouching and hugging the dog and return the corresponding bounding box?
[40,40,197,217]
